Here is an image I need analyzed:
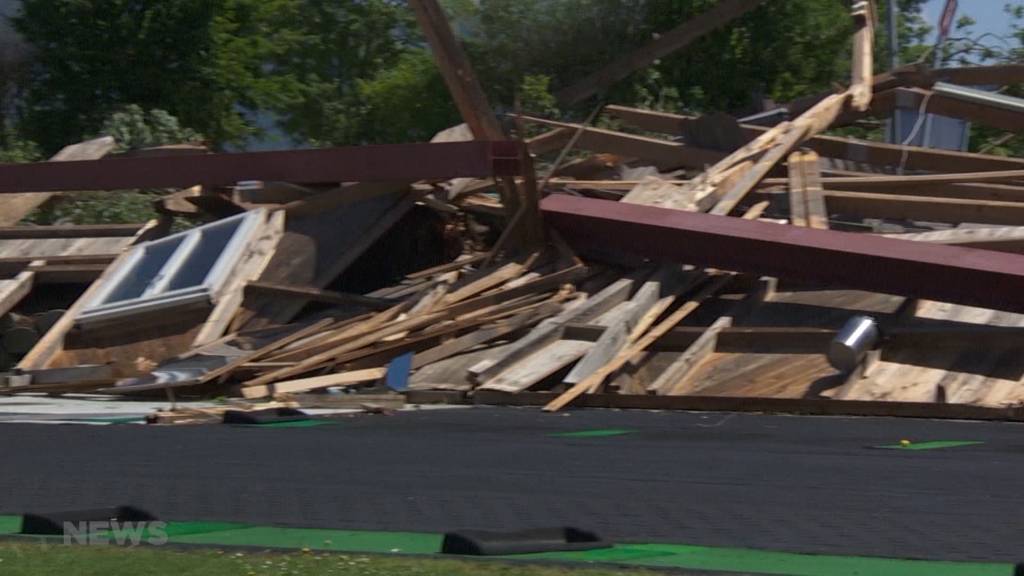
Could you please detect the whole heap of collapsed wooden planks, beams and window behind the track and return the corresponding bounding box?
[6,0,1024,419]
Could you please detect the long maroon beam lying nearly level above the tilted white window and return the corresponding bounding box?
[0,140,523,194]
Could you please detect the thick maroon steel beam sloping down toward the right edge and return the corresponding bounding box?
[541,195,1024,312]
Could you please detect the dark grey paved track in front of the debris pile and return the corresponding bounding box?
[0,408,1024,562]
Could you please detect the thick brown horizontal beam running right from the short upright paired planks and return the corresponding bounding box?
[825,190,1024,225]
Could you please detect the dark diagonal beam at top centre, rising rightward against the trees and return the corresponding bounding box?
[555,0,765,105]
